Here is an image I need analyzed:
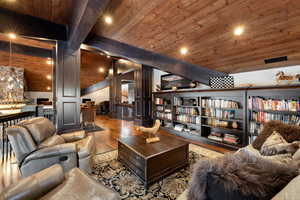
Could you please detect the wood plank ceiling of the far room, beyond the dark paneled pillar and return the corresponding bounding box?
[0,34,111,92]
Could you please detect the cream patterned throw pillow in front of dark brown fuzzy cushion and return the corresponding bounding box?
[260,131,287,156]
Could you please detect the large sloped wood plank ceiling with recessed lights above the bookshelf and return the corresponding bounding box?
[94,0,300,73]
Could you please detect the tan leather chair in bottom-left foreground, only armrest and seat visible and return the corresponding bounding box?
[0,164,120,200]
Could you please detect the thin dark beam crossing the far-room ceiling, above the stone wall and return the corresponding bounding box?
[0,41,52,58]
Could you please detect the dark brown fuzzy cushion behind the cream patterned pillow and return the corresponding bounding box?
[252,121,300,150]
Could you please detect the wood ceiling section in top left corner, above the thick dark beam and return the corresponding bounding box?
[0,0,74,25]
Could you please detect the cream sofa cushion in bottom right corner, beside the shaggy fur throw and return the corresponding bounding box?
[272,175,300,200]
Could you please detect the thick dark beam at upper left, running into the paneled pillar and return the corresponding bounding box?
[0,8,67,40]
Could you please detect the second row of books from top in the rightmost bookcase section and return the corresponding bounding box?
[249,112,300,125]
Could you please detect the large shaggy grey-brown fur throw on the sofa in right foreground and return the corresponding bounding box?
[188,152,298,200]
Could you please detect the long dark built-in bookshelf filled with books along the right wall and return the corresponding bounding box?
[153,87,300,149]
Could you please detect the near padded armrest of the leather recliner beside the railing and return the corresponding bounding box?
[24,143,77,163]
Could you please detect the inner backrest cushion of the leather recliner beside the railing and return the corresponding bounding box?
[19,117,56,145]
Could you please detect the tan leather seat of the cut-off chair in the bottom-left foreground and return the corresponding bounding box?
[41,168,120,200]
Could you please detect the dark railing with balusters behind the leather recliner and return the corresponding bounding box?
[0,112,36,163]
